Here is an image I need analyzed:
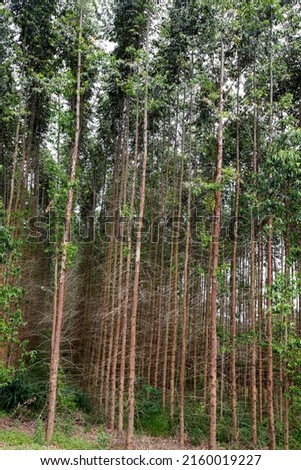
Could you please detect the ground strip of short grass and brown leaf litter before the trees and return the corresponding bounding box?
[0,415,205,450]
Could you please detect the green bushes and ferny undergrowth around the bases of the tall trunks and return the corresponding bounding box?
[0,373,301,450]
